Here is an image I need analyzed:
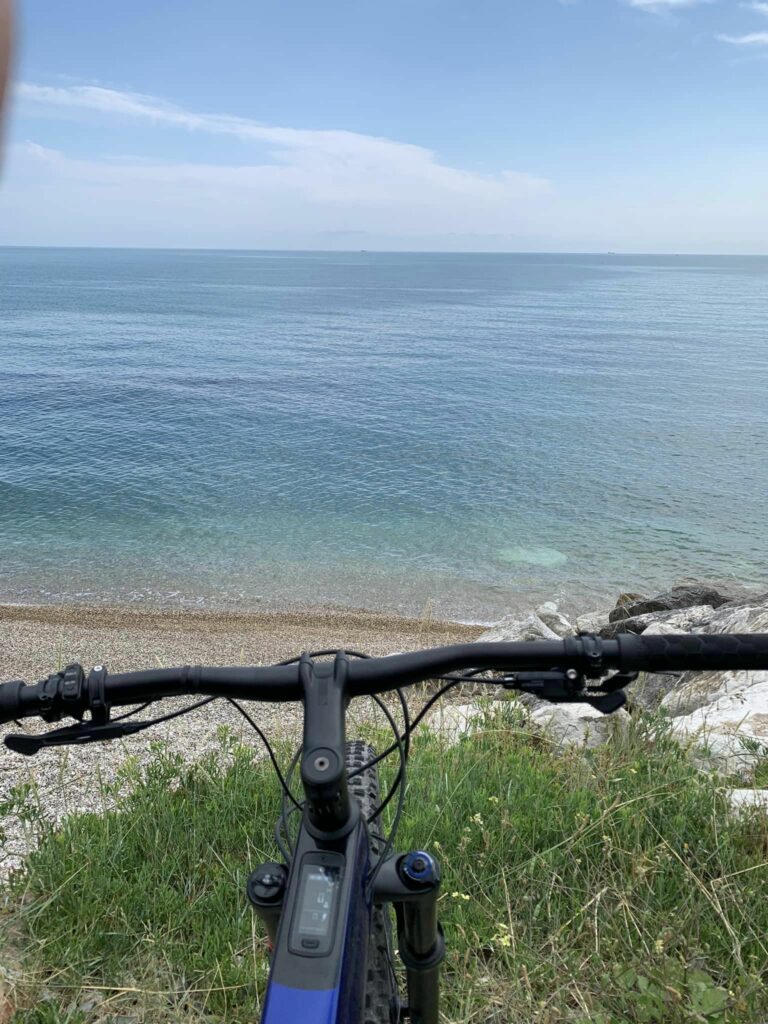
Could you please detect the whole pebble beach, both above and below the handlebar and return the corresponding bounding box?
[0,605,481,877]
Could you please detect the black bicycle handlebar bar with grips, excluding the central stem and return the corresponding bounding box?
[0,633,768,725]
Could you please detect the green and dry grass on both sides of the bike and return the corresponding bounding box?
[0,708,768,1024]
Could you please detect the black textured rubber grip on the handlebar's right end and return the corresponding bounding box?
[616,633,768,672]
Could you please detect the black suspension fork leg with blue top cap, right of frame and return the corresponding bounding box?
[374,850,445,1024]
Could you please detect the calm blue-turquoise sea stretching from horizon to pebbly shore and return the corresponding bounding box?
[0,249,768,620]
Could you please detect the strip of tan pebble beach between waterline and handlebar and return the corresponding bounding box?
[0,603,484,681]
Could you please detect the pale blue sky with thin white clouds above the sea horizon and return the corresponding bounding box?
[0,0,768,254]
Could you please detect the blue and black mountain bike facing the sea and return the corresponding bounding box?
[0,634,768,1024]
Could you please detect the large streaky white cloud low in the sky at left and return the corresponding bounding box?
[6,84,552,247]
